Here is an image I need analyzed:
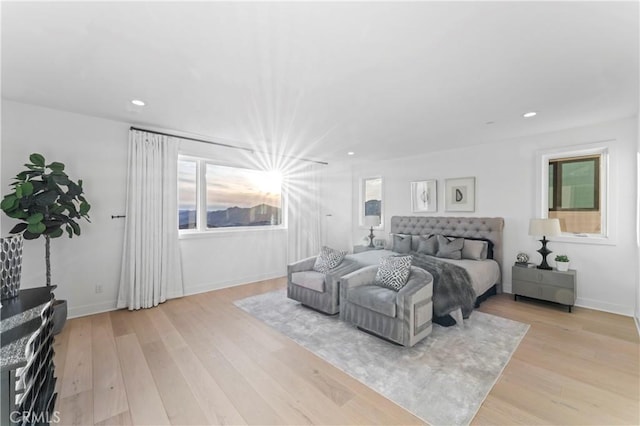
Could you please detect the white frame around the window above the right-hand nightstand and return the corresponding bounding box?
[534,140,616,245]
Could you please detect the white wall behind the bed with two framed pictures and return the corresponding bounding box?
[344,117,638,315]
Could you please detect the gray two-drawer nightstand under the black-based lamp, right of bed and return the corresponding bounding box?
[511,266,577,312]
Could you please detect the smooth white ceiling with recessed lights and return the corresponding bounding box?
[1,1,640,161]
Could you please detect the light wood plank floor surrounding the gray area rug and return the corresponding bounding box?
[55,279,640,425]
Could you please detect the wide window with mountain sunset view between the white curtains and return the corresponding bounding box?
[178,157,283,231]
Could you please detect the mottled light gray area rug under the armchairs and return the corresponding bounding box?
[234,289,529,425]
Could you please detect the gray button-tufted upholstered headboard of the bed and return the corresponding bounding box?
[391,216,504,293]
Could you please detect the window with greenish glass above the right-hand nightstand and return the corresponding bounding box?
[540,143,610,242]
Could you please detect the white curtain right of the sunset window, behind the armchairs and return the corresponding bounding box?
[287,164,322,262]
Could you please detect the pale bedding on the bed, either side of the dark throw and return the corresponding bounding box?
[346,250,500,296]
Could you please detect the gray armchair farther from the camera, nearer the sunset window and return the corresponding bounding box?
[287,256,361,315]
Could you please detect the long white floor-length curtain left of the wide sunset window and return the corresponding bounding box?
[118,130,184,310]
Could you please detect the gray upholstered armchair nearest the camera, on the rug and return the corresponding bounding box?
[340,265,433,346]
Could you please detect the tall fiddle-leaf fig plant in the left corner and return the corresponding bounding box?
[0,153,91,333]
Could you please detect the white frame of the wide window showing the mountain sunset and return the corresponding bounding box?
[176,154,287,238]
